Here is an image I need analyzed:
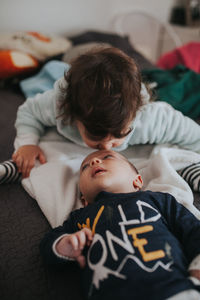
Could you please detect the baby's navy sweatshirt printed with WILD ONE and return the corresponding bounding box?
[40,191,200,300]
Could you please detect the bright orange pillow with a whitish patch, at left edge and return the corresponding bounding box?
[0,50,39,79]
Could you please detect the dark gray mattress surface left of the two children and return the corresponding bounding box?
[0,89,82,300]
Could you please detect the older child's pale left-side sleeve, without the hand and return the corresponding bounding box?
[15,78,67,148]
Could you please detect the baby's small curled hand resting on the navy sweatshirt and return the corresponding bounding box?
[56,228,93,268]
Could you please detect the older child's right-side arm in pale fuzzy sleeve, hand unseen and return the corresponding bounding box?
[128,101,200,153]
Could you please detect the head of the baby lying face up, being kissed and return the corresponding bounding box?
[79,150,143,205]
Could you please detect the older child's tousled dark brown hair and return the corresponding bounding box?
[60,47,142,140]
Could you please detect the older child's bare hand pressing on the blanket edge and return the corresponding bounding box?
[12,145,46,178]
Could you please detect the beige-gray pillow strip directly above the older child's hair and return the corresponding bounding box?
[62,42,111,63]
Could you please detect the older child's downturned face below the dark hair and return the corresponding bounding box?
[76,121,130,150]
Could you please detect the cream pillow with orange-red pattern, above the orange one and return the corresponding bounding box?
[0,32,71,61]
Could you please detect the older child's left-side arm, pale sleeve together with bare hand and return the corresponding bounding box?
[12,79,63,178]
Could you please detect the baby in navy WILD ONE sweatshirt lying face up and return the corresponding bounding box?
[40,150,200,300]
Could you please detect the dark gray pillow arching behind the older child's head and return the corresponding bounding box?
[69,31,155,70]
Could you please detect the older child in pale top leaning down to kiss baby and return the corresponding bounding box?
[0,47,200,189]
